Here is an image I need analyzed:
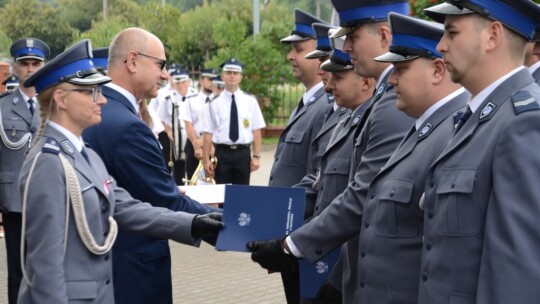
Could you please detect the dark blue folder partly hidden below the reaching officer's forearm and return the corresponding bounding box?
[298,246,341,299]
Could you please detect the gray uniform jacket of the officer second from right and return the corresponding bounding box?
[356,90,469,304]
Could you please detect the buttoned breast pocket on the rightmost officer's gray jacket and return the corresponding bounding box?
[435,168,481,236]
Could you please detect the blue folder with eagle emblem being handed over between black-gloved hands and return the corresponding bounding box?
[215,185,306,252]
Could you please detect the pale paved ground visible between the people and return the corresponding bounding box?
[0,146,285,304]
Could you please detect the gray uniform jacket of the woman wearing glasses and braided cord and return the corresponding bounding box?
[18,126,200,304]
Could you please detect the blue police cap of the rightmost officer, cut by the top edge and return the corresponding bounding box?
[424,0,540,41]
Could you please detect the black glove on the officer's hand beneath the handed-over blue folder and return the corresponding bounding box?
[246,240,298,272]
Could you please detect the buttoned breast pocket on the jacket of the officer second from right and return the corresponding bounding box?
[375,178,422,237]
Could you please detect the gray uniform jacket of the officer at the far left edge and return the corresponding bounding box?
[0,89,40,213]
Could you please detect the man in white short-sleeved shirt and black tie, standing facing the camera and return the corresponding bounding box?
[203,58,266,185]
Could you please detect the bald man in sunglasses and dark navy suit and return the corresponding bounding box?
[83,28,213,304]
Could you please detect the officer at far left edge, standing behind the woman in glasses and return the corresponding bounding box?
[0,38,50,304]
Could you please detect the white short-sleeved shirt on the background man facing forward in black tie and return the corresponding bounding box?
[203,90,266,145]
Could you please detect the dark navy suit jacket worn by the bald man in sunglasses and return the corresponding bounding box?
[83,86,212,304]
